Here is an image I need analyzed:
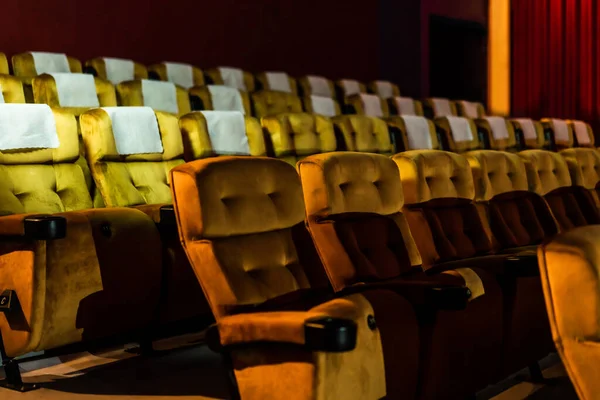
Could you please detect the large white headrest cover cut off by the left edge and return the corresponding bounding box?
[0,104,59,151]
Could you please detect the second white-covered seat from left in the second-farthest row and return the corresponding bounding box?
[116,79,192,116]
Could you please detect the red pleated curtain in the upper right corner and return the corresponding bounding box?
[511,0,600,135]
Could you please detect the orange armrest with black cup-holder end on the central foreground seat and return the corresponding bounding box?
[206,311,357,352]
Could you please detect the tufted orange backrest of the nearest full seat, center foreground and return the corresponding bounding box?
[166,156,310,320]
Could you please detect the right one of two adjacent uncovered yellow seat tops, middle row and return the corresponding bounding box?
[332,115,393,154]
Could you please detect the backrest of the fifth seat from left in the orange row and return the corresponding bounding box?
[519,150,600,231]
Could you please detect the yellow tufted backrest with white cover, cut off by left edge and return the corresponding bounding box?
[0,104,93,215]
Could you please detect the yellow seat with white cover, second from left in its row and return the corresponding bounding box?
[80,107,208,324]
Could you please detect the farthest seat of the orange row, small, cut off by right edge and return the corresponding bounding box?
[560,148,600,208]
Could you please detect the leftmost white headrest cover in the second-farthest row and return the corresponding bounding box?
[50,72,100,108]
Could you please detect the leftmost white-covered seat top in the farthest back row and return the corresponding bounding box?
[12,52,82,78]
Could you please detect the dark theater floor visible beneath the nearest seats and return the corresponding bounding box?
[0,335,577,400]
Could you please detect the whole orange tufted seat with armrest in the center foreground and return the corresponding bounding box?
[171,157,418,400]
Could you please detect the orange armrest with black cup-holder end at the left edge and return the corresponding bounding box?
[0,214,67,240]
